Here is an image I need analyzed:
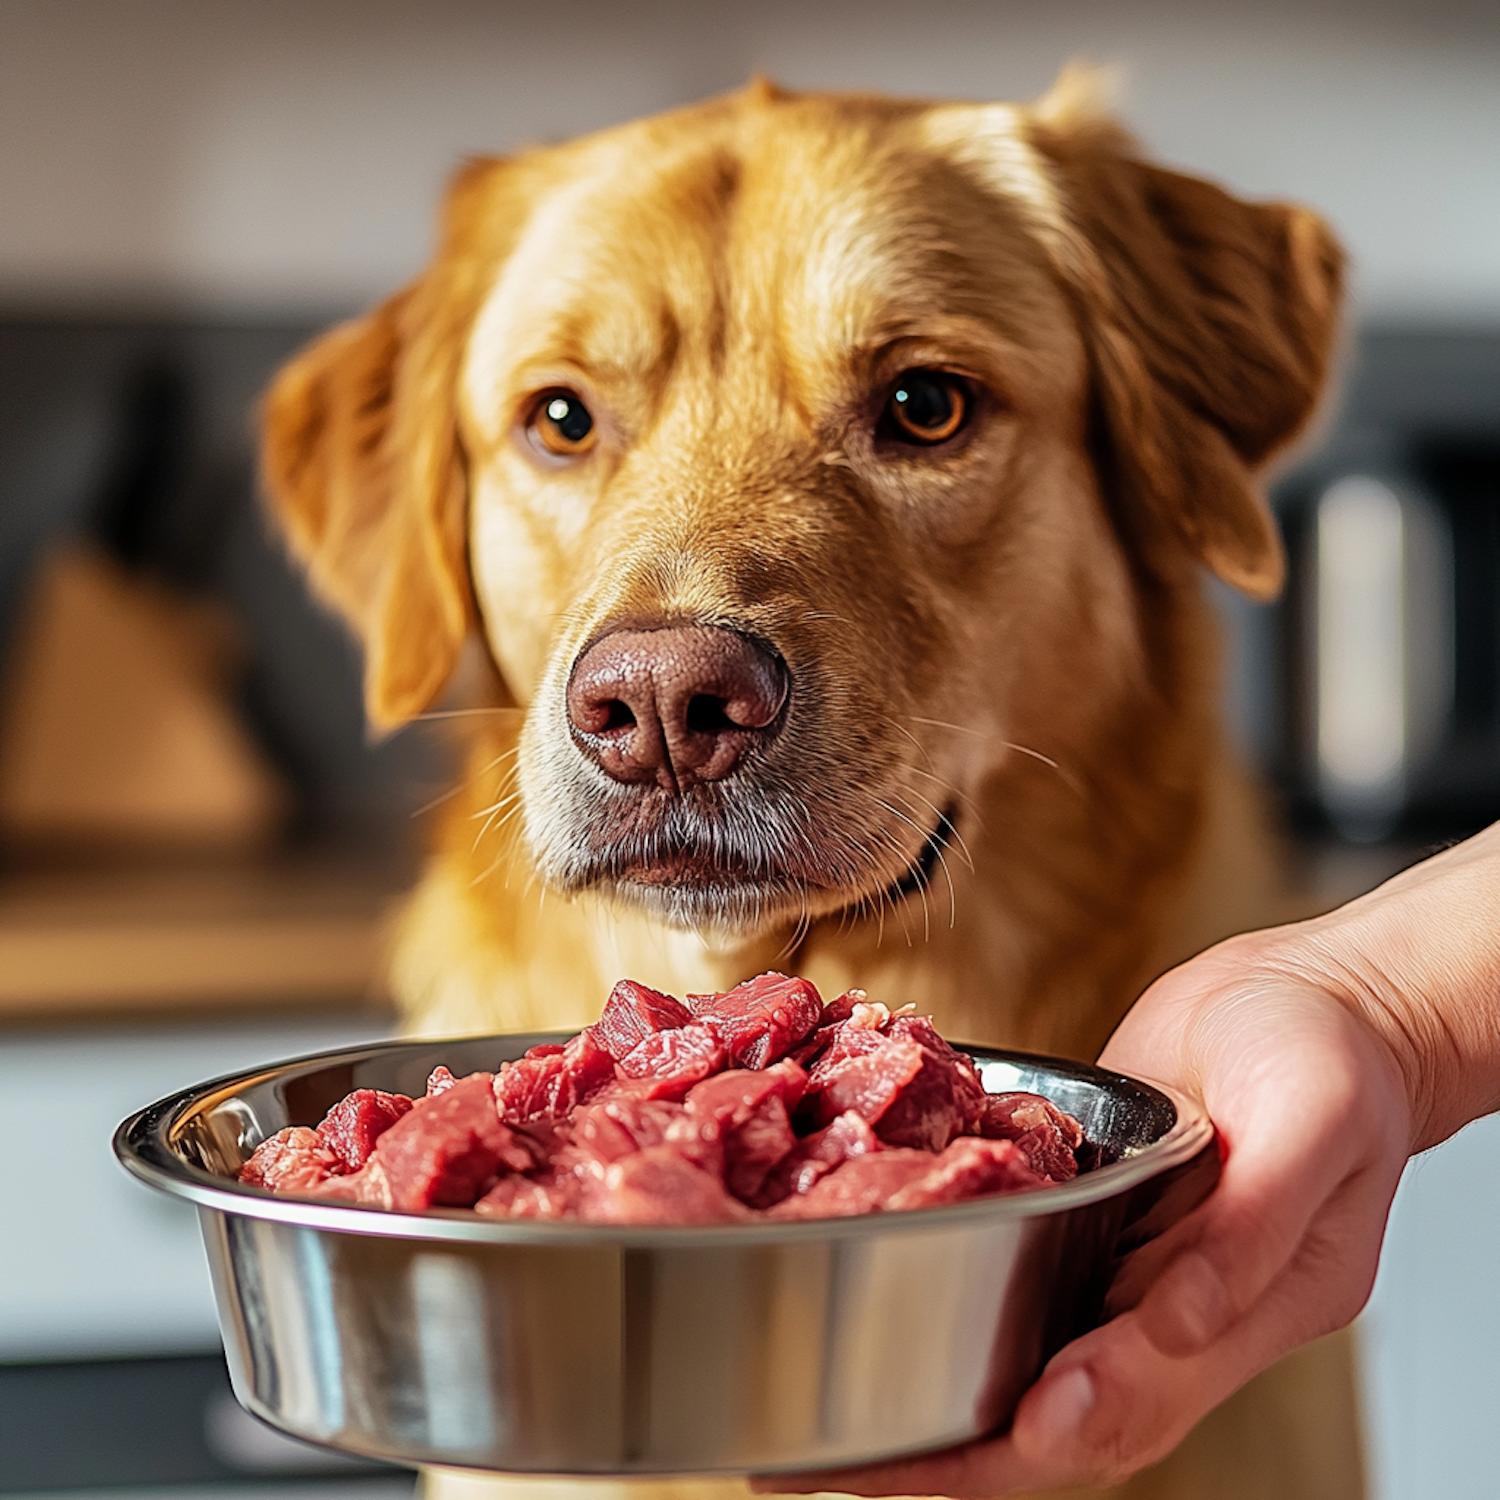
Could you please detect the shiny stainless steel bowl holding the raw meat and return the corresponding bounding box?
[114,1035,1218,1475]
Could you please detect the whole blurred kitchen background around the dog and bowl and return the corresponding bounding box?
[0,0,1500,1500]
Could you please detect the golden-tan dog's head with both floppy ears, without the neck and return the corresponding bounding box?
[267,73,1340,930]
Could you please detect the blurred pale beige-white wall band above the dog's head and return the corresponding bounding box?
[0,0,1500,321]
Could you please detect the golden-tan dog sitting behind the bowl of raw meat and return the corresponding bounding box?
[264,71,1361,1500]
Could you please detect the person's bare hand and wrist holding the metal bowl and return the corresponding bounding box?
[759,824,1500,1497]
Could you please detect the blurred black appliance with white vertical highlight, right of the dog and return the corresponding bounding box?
[1262,332,1500,840]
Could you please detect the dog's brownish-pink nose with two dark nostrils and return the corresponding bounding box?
[567,626,791,791]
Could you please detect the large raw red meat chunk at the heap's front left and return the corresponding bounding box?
[375,1073,531,1214]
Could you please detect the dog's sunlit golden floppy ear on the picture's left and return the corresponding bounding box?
[263,161,513,729]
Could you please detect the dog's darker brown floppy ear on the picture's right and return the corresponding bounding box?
[1025,74,1344,600]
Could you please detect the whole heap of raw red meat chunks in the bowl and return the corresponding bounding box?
[240,974,1092,1224]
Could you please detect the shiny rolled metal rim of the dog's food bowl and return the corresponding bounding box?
[113,1032,1214,1248]
